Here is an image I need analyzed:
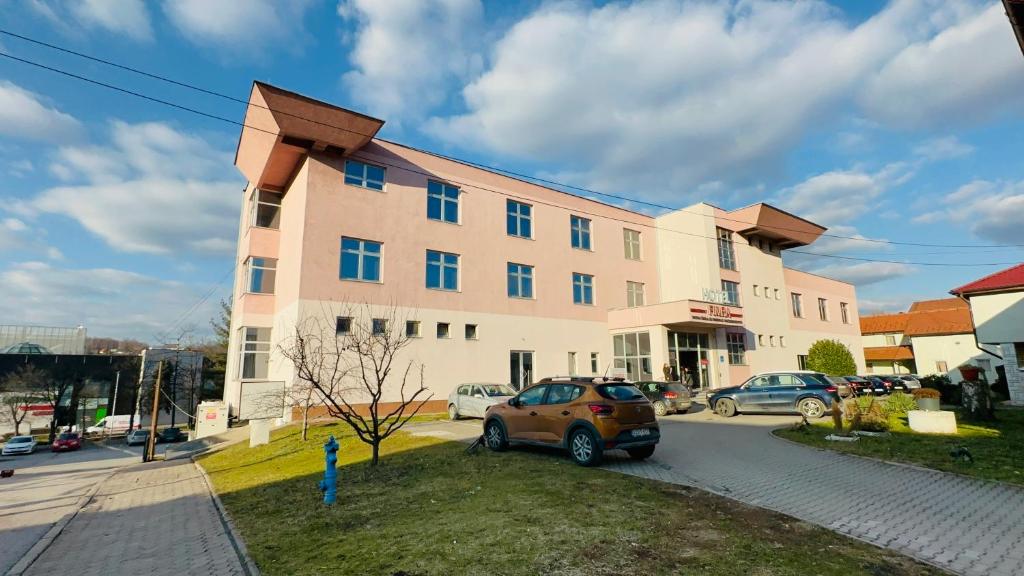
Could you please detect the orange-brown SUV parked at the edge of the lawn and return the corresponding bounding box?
[483,376,662,466]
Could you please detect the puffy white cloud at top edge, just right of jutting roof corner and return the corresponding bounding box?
[338,0,483,123]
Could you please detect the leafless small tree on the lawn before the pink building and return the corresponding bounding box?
[279,304,433,465]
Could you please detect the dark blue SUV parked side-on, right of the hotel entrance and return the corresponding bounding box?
[708,370,839,418]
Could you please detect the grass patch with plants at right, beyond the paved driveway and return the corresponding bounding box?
[775,409,1024,485]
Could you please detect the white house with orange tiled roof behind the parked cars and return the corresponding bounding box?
[860,298,1001,382]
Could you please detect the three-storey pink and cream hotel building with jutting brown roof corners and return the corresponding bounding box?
[225,83,863,413]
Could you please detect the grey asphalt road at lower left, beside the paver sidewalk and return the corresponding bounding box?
[0,434,173,574]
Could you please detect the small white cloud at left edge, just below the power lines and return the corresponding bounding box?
[0,80,82,141]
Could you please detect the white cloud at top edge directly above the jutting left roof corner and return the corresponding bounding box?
[163,0,310,55]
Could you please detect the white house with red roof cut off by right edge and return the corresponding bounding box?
[949,264,1024,405]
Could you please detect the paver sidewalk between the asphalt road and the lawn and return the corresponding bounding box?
[26,458,245,576]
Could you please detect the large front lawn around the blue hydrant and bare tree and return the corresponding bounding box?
[200,424,939,576]
